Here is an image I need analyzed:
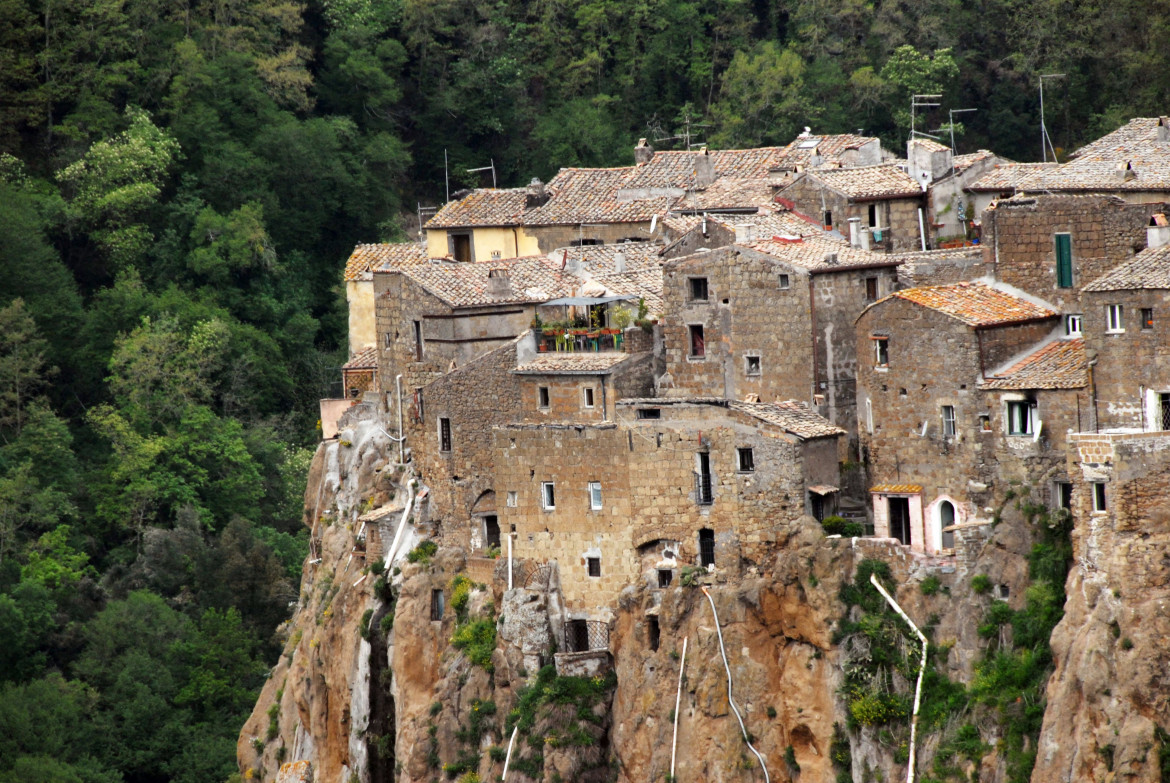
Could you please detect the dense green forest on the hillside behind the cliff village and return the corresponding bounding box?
[0,0,1170,783]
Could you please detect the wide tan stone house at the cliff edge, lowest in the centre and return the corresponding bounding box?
[494,398,845,618]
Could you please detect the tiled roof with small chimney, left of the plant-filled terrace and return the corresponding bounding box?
[400,255,581,307]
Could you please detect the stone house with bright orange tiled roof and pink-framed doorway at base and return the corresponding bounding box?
[856,282,1088,554]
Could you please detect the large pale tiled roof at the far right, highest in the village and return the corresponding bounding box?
[1027,117,1170,191]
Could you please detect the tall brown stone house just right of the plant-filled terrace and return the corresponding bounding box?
[660,236,897,440]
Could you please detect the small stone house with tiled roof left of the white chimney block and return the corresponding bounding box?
[777,163,930,252]
